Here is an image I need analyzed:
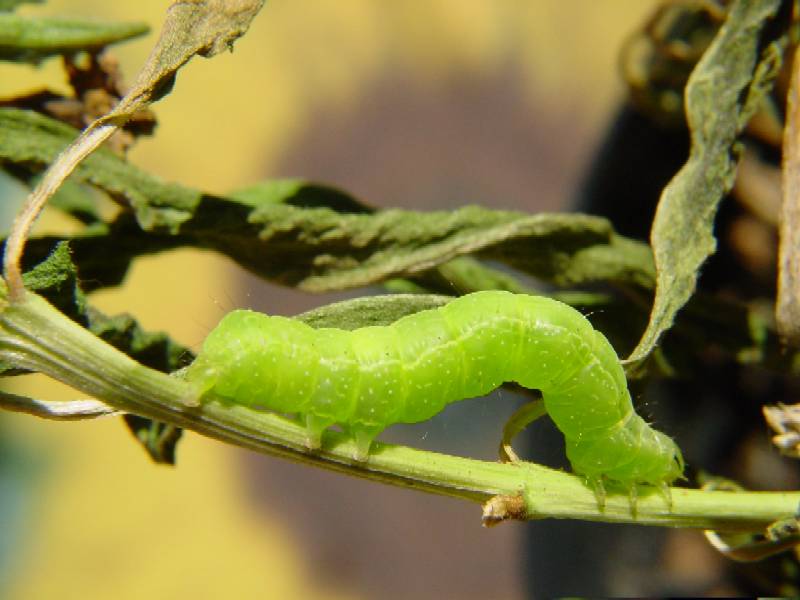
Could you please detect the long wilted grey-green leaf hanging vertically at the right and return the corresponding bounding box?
[629,0,786,361]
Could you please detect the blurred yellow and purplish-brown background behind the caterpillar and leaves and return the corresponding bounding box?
[0,0,653,599]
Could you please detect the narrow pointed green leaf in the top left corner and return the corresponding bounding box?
[0,13,150,62]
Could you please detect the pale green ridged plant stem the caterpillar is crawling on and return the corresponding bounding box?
[0,285,800,531]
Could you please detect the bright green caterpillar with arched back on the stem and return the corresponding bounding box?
[186,291,683,489]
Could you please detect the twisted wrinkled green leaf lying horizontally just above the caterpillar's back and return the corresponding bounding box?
[247,205,653,292]
